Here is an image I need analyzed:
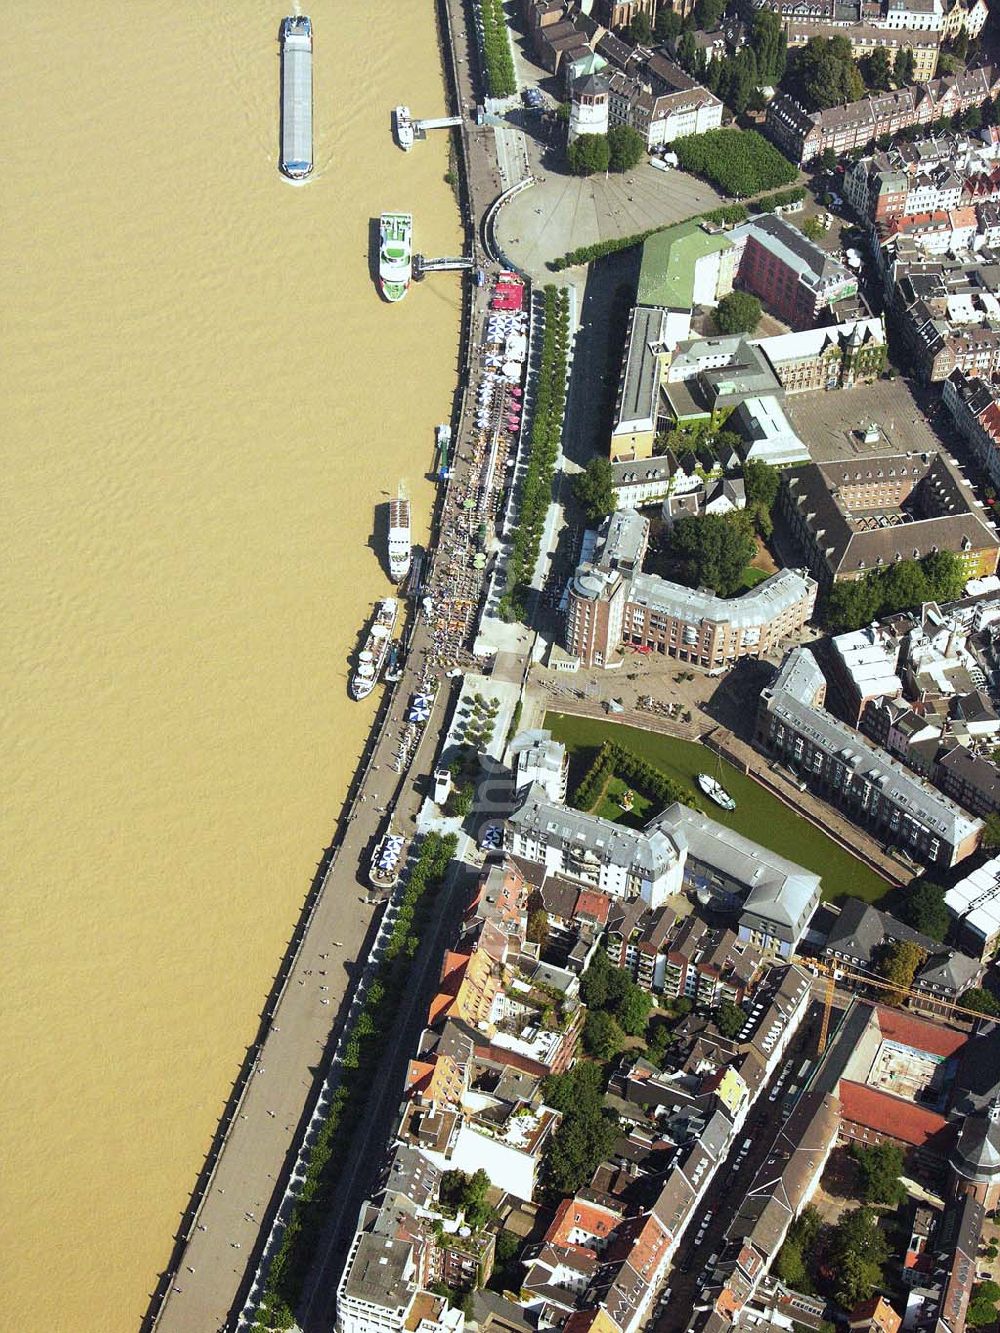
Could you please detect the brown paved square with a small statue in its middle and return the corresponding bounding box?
[784,377,941,463]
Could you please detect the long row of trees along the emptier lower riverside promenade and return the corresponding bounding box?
[253,833,457,1329]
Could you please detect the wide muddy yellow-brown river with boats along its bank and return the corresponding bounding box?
[0,0,460,1333]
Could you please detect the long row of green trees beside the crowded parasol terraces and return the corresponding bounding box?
[497,285,569,621]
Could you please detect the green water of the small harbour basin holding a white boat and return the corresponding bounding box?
[545,713,892,902]
